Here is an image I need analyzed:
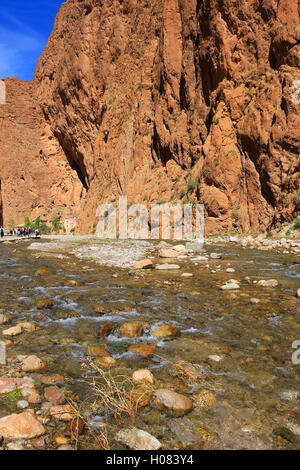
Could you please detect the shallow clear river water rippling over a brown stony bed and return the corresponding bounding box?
[0,241,300,449]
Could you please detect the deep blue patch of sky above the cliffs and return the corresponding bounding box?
[0,0,63,81]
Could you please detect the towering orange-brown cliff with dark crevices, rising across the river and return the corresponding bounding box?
[0,0,300,233]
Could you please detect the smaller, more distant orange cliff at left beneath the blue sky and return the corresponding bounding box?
[0,78,82,228]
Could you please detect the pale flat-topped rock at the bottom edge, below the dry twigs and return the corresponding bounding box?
[115,428,161,450]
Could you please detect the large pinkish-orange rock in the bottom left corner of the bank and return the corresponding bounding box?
[0,411,45,439]
